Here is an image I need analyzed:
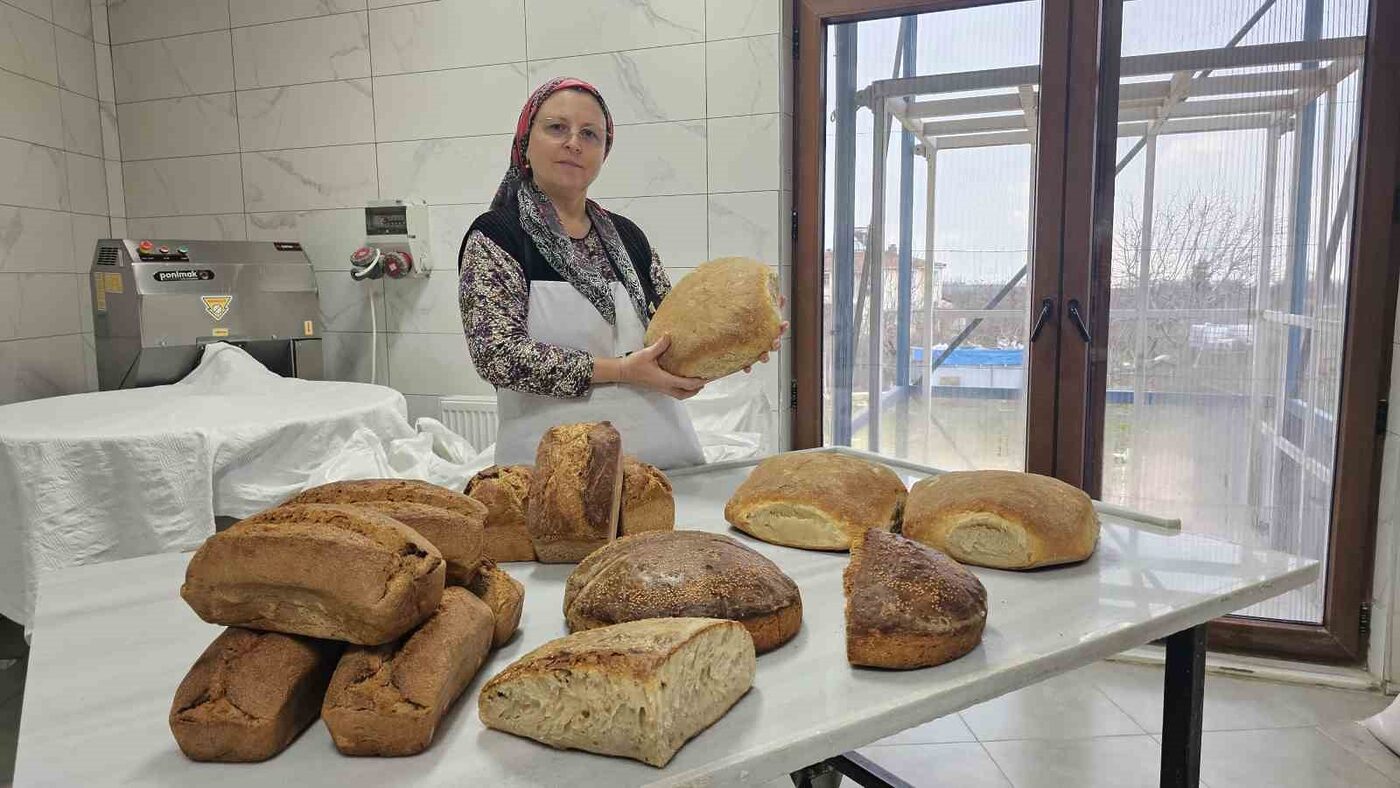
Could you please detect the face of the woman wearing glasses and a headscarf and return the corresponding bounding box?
[525,90,608,195]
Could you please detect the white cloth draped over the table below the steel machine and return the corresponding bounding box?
[0,344,416,627]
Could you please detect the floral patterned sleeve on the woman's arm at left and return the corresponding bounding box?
[458,231,594,397]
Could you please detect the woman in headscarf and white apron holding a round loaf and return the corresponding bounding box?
[458,78,785,469]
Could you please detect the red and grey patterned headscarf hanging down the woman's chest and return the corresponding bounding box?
[491,77,650,326]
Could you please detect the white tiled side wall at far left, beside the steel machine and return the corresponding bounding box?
[0,0,120,404]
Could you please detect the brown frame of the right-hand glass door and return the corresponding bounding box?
[1075,0,1400,663]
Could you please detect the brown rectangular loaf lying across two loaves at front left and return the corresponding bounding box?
[181,504,447,645]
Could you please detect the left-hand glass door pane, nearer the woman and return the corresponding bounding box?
[820,0,1063,473]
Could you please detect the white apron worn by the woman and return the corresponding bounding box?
[496,281,704,469]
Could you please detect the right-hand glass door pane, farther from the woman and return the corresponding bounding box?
[1089,0,1389,660]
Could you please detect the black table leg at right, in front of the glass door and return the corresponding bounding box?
[1162,624,1205,788]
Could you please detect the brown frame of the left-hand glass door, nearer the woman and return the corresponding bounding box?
[792,0,1095,474]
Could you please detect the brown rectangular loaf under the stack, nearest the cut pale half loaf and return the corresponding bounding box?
[321,586,491,756]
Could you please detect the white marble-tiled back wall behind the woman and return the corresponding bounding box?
[100,0,791,445]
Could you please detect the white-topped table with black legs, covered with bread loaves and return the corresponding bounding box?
[15,450,1317,788]
